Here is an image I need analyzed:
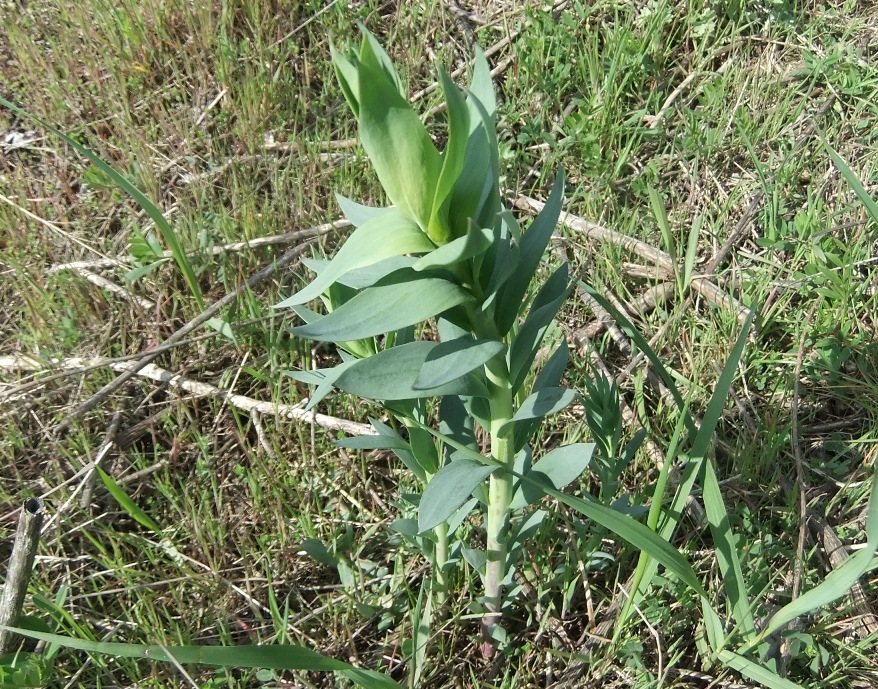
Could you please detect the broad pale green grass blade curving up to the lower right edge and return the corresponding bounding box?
[760,468,878,638]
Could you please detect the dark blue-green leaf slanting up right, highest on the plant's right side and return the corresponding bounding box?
[496,171,564,334]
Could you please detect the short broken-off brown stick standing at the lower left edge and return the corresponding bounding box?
[0,498,43,655]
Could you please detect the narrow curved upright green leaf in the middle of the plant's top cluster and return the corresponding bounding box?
[429,67,469,237]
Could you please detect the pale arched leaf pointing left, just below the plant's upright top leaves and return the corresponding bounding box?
[275,211,436,306]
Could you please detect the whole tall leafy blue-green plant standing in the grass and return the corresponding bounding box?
[278,25,594,653]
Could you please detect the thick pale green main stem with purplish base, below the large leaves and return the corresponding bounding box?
[482,357,515,656]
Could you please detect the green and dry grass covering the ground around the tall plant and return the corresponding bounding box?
[0,0,878,688]
